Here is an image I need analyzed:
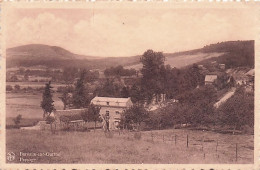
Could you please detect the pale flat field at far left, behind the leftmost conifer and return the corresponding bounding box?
[6,93,63,120]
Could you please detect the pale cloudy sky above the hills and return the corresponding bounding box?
[6,8,257,57]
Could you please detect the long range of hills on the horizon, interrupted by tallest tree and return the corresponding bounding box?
[7,41,254,69]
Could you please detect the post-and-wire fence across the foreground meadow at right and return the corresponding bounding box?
[107,131,254,162]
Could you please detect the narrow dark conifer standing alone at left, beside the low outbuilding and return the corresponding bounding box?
[41,81,55,118]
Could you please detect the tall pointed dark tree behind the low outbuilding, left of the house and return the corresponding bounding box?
[72,70,90,108]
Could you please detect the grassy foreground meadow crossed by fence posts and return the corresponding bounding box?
[6,129,254,164]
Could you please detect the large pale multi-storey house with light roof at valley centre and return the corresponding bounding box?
[91,97,133,130]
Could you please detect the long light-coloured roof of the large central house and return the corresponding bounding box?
[91,97,132,107]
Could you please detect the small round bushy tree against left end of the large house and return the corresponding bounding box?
[81,104,101,130]
